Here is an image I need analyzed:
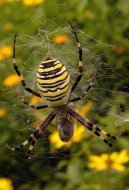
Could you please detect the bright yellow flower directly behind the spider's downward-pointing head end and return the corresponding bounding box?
[49,126,86,149]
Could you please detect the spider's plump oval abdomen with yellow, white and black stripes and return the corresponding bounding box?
[37,57,71,107]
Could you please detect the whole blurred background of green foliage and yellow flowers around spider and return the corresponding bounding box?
[0,0,129,190]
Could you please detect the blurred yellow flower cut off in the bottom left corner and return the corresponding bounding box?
[0,178,13,190]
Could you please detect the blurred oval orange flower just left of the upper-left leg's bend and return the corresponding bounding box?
[3,74,20,87]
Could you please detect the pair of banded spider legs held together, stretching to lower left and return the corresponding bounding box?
[7,111,56,159]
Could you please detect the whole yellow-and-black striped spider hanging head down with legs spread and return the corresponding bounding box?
[9,21,117,159]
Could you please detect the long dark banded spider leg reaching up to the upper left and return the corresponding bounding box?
[13,34,41,98]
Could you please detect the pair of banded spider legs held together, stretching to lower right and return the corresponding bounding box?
[68,107,118,147]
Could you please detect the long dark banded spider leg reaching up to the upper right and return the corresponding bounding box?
[68,20,82,91]
